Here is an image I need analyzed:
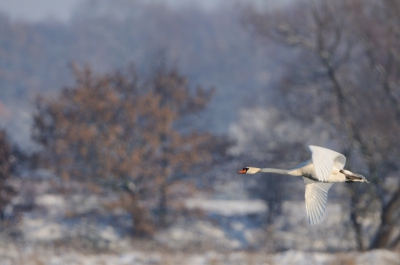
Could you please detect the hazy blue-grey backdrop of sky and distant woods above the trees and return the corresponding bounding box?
[0,0,278,147]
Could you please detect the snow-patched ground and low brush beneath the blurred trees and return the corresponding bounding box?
[0,179,400,265]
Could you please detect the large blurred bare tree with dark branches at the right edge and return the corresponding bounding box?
[246,0,400,250]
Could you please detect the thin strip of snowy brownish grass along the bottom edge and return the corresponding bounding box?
[0,246,400,265]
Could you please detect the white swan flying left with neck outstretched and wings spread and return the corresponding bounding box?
[238,145,369,225]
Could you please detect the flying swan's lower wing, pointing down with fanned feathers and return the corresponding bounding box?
[303,178,333,225]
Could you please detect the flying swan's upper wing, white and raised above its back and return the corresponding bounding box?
[308,145,346,181]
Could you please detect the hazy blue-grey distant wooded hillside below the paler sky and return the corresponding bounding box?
[0,0,269,143]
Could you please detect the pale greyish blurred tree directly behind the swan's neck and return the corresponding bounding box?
[231,108,313,227]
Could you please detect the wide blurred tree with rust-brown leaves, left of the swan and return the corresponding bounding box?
[33,64,227,235]
